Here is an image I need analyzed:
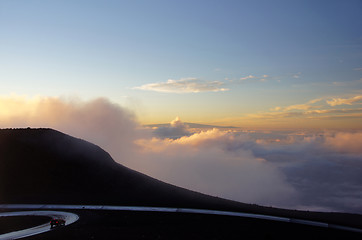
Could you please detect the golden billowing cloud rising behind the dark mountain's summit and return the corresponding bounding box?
[0,97,139,161]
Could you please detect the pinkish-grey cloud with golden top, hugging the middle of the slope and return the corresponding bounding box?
[138,129,295,206]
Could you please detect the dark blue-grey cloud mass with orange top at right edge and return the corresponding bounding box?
[253,131,362,213]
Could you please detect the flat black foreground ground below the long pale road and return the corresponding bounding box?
[24,210,361,240]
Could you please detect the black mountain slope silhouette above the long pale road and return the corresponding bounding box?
[0,128,362,227]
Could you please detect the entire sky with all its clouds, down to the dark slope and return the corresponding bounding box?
[0,0,362,214]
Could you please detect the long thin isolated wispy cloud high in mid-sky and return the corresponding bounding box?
[134,78,229,93]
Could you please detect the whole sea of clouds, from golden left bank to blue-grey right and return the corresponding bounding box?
[0,97,362,213]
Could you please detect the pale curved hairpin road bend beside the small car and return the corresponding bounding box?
[0,211,79,240]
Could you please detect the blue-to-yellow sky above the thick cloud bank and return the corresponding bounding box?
[0,0,362,129]
